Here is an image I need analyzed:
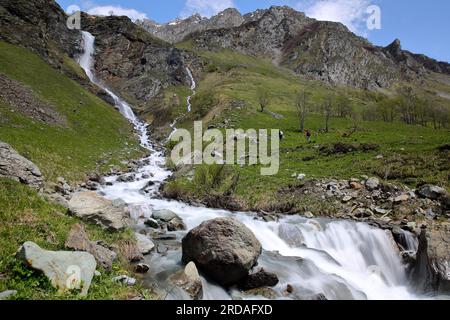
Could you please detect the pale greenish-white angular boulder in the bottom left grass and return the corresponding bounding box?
[16,242,97,296]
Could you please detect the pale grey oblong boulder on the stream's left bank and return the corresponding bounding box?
[69,191,131,231]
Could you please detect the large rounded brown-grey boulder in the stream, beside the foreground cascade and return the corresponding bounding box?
[182,218,262,287]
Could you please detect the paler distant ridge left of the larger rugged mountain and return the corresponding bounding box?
[137,8,244,43]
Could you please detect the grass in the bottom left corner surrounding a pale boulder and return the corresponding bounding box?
[0,179,153,299]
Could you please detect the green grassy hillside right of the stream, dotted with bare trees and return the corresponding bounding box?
[166,43,450,208]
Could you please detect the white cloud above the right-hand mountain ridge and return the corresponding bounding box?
[296,0,371,35]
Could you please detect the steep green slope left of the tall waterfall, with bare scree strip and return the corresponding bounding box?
[0,42,139,180]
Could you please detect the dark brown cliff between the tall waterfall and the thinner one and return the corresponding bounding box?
[82,15,197,115]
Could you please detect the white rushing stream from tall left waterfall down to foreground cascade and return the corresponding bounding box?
[79,32,422,299]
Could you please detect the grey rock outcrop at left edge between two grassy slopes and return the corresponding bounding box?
[0,141,43,188]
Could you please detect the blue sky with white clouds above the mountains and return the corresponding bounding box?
[57,0,450,62]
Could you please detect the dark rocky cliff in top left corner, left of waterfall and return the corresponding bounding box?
[0,0,81,68]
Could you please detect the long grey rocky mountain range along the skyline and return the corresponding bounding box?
[140,6,450,89]
